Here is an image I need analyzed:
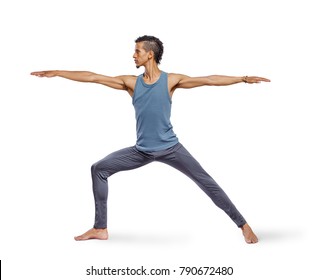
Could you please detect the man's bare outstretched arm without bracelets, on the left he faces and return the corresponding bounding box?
[31,70,134,93]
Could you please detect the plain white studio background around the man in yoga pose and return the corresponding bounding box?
[0,0,318,280]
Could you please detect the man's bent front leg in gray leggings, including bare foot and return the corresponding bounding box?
[75,146,153,240]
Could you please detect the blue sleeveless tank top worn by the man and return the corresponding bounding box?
[132,72,178,152]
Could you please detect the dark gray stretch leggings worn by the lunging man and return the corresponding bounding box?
[91,143,246,228]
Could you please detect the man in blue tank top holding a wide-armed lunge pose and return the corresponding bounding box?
[31,35,269,243]
